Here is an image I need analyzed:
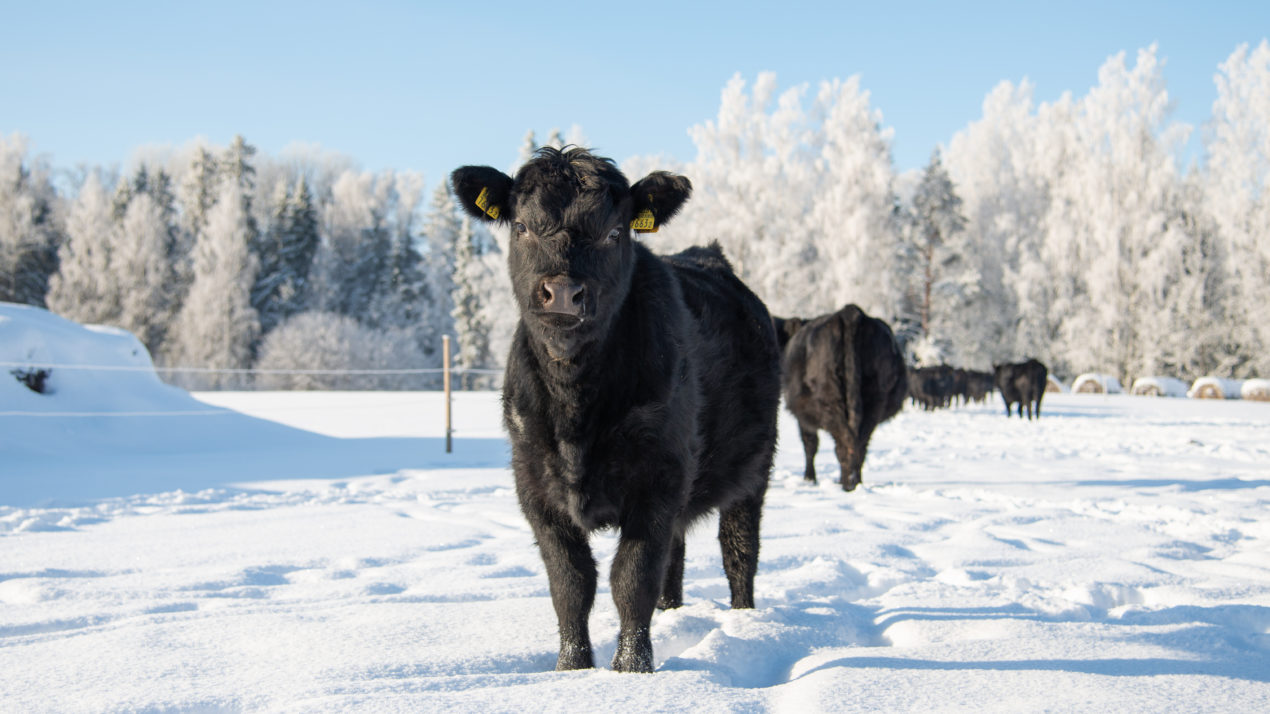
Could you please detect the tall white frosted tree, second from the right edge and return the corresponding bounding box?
[1045,47,1189,384]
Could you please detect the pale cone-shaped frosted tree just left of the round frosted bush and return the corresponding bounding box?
[165,182,260,389]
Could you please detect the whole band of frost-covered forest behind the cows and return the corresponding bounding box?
[0,41,1270,389]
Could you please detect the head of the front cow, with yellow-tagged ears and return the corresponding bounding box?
[451,147,692,358]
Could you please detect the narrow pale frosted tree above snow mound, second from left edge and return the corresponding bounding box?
[47,172,121,325]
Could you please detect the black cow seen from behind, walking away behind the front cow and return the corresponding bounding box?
[776,305,908,490]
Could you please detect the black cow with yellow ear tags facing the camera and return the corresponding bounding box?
[451,149,780,672]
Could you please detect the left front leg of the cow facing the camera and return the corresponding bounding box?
[530,505,596,671]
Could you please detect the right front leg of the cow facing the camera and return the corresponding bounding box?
[611,508,673,672]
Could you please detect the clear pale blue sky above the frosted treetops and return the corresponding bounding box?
[0,0,1270,185]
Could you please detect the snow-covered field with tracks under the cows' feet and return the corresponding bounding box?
[0,302,1270,713]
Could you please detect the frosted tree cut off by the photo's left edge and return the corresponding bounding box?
[0,135,61,306]
